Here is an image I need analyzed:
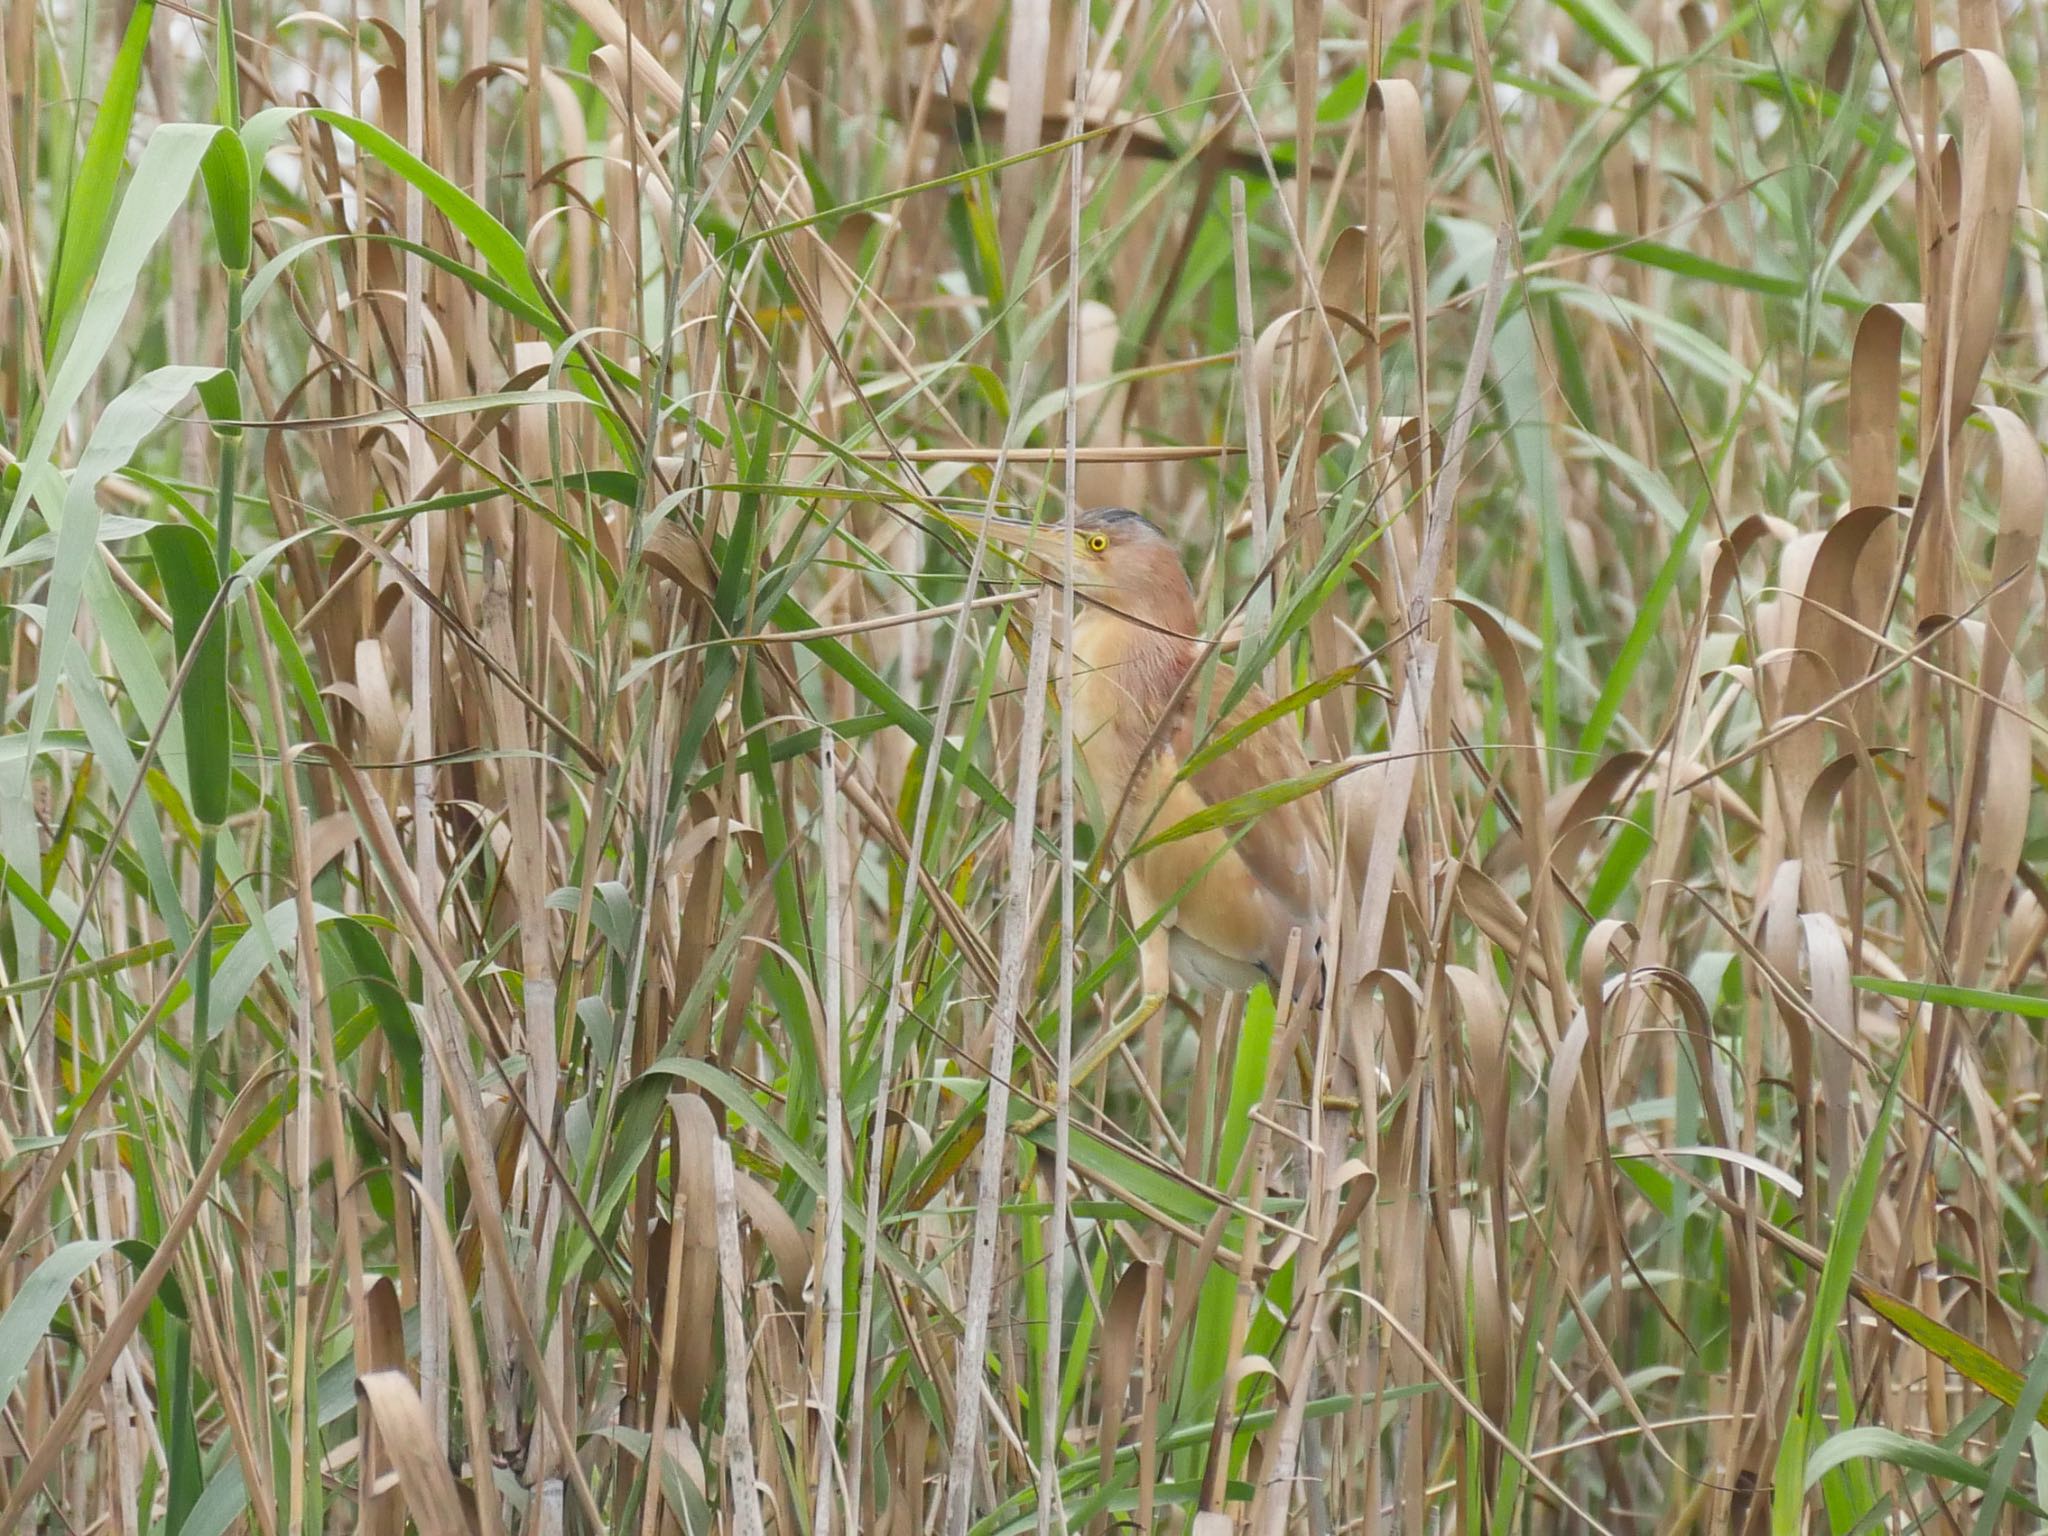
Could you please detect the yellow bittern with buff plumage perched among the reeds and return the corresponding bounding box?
[967,508,1331,1083]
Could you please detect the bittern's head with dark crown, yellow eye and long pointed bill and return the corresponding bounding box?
[965,506,1196,637]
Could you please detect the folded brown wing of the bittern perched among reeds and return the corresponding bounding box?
[1188,668,1331,930]
